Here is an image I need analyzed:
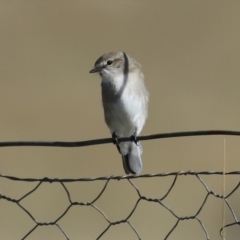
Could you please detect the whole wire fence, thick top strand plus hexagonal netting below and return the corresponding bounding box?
[0,130,240,239]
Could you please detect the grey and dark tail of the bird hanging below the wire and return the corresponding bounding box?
[122,142,142,174]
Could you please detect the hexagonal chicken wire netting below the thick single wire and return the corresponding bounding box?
[0,171,240,239]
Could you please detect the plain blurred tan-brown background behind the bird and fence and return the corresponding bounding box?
[0,0,240,240]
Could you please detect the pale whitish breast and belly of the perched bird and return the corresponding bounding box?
[102,74,147,136]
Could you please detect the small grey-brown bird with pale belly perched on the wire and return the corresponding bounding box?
[90,52,149,174]
